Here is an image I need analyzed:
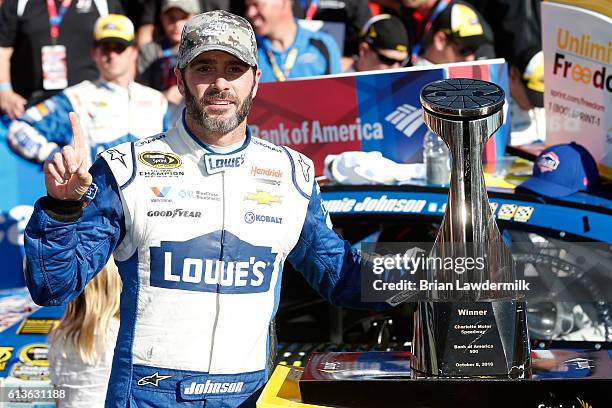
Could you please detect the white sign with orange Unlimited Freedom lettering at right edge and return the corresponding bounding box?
[542,1,612,175]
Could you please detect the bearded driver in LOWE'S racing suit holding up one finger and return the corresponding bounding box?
[25,11,376,408]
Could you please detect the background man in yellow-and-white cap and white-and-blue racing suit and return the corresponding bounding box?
[8,14,168,163]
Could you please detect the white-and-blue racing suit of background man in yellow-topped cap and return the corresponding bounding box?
[7,80,169,162]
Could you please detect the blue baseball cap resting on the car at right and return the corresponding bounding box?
[519,142,599,197]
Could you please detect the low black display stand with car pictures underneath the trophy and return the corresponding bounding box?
[299,350,612,408]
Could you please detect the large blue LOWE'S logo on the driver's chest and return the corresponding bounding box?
[150,231,276,294]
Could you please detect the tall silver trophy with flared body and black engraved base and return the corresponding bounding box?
[413,79,529,378]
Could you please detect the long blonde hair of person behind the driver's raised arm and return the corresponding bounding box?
[51,257,121,365]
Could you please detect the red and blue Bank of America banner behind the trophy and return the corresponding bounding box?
[249,59,510,175]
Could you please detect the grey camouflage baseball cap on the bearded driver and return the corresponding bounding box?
[178,10,257,69]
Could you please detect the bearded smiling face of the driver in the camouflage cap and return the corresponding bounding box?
[177,51,261,135]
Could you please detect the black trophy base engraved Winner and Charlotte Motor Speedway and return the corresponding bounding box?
[412,300,529,379]
